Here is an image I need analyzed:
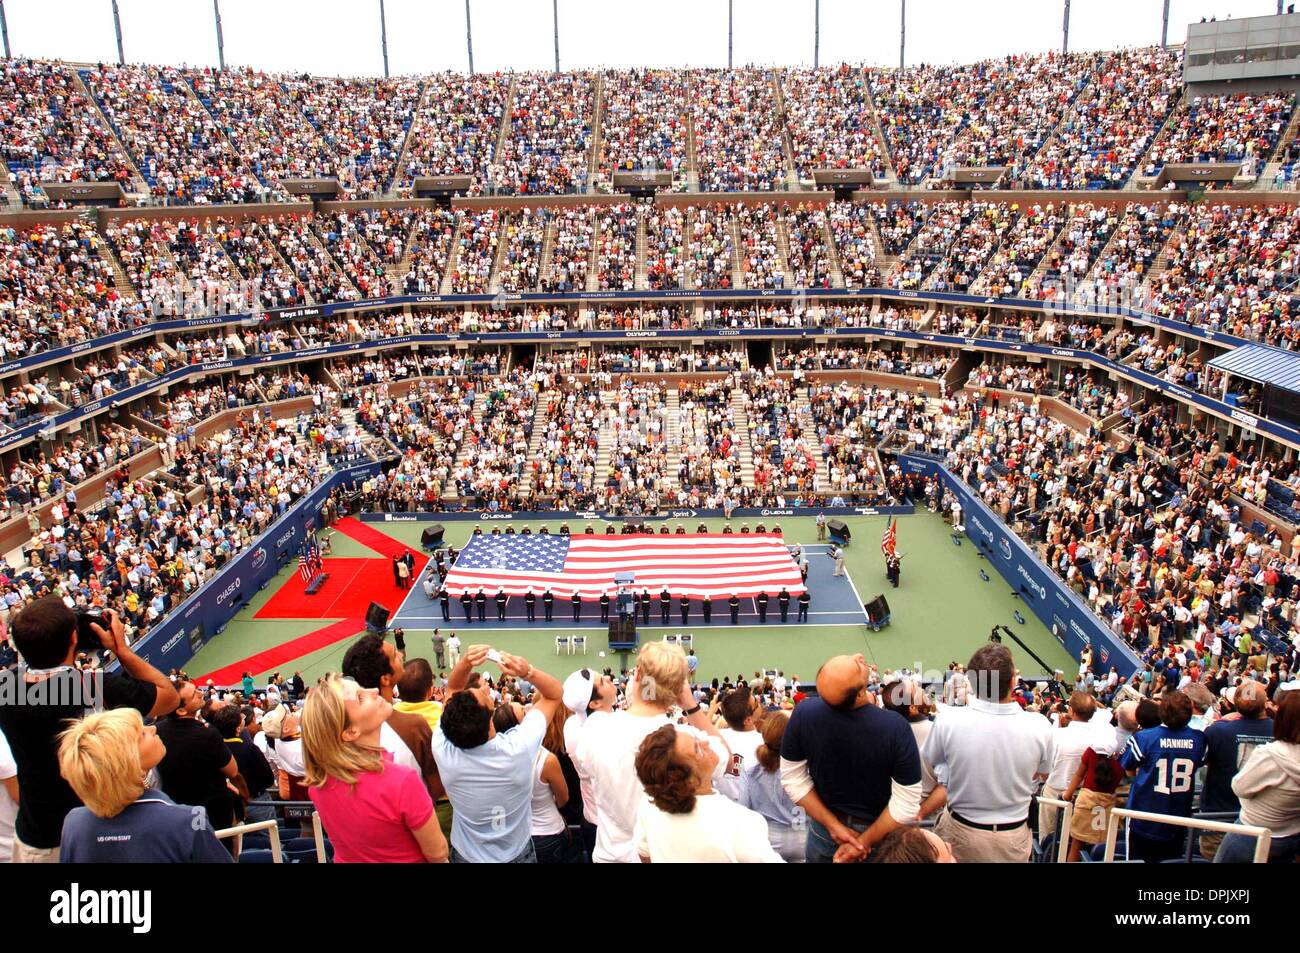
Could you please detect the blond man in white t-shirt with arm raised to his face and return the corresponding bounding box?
[573,642,731,863]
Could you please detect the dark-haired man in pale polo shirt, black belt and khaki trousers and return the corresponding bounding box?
[922,642,1056,863]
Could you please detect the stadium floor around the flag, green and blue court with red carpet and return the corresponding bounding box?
[187,508,1078,684]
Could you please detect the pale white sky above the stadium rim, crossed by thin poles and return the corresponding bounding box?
[4,0,1277,75]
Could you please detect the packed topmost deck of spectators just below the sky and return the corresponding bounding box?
[10,48,1295,207]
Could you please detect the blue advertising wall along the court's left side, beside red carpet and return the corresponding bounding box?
[114,463,381,672]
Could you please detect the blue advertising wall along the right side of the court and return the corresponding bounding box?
[898,454,1141,677]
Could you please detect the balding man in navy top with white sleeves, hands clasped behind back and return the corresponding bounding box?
[781,655,920,863]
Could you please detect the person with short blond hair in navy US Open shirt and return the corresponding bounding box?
[59,709,230,863]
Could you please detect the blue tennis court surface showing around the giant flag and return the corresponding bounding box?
[389,545,867,631]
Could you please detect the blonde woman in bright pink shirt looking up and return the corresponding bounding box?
[302,673,449,863]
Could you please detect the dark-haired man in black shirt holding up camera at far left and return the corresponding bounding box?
[0,595,179,863]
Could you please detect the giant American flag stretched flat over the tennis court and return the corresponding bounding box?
[446,533,805,599]
